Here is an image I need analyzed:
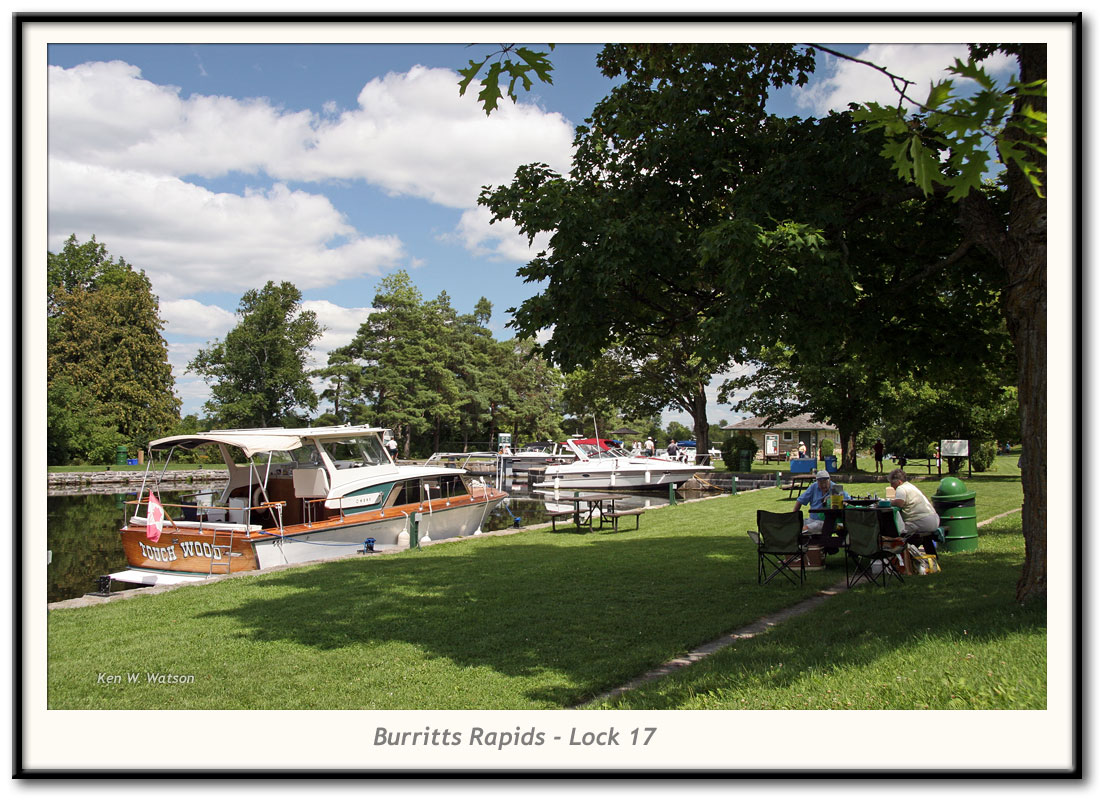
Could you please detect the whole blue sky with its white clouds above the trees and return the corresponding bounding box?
[48,37,1012,429]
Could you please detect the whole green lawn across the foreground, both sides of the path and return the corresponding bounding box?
[48,476,1045,709]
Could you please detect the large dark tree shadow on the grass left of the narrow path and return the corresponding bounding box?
[191,531,824,708]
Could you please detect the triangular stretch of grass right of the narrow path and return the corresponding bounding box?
[594,516,1046,710]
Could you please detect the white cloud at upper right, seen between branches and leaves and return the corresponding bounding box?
[794,44,1012,114]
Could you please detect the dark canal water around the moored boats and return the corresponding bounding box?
[46,483,712,603]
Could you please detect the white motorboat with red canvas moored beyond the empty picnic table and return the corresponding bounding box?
[535,439,714,490]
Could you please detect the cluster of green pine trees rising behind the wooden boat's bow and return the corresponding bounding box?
[323,271,562,452]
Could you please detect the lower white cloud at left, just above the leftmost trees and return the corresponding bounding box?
[50,158,407,299]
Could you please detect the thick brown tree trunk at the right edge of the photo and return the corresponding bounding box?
[960,44,1047,603]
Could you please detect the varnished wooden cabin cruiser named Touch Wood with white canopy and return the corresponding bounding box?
[111,426,507,584]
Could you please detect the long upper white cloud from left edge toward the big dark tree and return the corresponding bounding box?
[50,62,573,208]
